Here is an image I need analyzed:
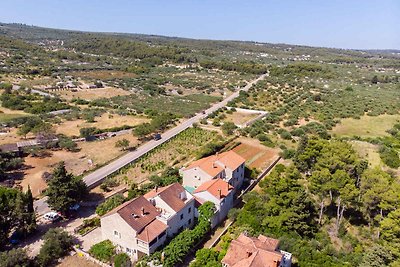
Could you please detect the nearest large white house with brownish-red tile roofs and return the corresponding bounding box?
[100,183,195,260]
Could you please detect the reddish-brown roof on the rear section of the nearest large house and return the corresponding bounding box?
[144,183,187,212]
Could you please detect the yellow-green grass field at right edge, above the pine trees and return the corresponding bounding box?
[331,115,400,137]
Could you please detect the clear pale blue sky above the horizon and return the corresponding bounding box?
[0,0,400,49]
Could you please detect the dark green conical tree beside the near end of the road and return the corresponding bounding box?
[46,162,87,214]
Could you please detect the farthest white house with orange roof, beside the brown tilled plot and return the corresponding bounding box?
[180,150,246,192]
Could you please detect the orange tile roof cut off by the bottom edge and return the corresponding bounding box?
[222,234,283,267]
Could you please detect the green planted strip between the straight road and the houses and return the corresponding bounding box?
[116,128,223,183]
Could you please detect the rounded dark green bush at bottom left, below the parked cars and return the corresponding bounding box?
[37,228,73,266]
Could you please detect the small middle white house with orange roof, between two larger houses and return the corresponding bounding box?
[193,178,234,228]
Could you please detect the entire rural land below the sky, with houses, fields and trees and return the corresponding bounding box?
[0,2,400,267]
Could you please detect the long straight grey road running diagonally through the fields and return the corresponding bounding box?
[34,74,268,214]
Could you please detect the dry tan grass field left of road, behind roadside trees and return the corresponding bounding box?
[56,113,150,136]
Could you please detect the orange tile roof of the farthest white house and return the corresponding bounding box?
[187,150,246,177]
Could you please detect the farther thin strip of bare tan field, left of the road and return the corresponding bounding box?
[54,87,131,100]
